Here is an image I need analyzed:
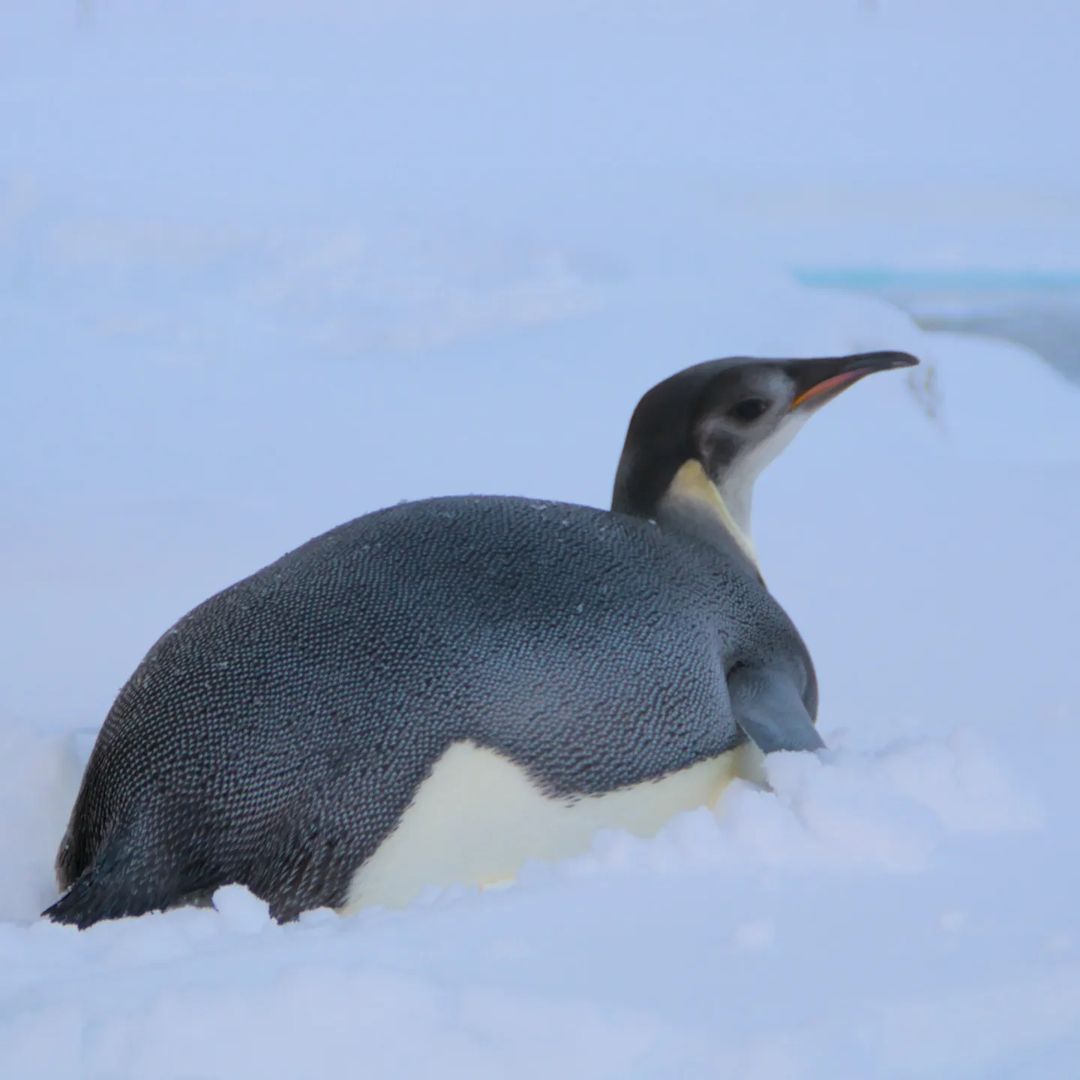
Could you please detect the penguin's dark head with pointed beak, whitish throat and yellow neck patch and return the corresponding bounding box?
[611,352,918,564]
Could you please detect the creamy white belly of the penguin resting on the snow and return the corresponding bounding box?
[341,742,756,914]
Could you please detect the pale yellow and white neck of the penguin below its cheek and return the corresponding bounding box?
[656,459,761,577]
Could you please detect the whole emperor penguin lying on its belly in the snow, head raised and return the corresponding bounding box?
[44,352,917,927]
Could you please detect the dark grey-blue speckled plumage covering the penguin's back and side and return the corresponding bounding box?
[46,354,915,926]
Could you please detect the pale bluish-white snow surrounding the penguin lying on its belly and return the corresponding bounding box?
[0,0,1080,1078]
